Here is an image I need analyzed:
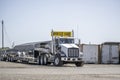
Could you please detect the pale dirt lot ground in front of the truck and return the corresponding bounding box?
[0,61,120,80]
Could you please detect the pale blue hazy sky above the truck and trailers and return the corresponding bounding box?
[0,0,120,47]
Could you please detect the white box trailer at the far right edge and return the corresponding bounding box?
[101,44,119,64]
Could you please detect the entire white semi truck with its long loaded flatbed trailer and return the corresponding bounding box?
[0,30,84,67]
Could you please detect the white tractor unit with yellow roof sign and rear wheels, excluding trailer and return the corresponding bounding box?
[35,31,84,66]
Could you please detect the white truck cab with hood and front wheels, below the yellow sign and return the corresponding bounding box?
[52,32,84,66]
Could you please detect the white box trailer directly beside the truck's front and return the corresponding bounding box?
[82,44,100,64]
